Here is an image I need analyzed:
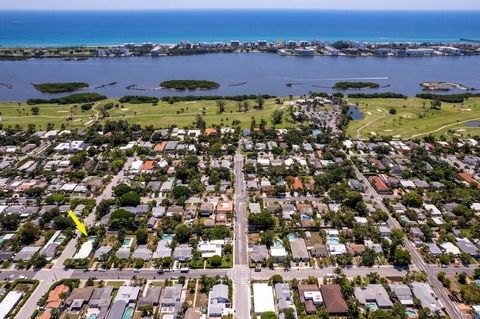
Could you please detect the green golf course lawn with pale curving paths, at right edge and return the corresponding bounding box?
[347,98,480,139]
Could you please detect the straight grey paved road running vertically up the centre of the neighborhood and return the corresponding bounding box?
[233,147,250,319]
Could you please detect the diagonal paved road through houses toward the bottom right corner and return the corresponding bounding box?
[353,154,463,319]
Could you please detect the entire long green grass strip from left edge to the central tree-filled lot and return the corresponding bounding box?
[0,99,294,130]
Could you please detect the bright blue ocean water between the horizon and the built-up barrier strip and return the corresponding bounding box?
[0,10,480,47]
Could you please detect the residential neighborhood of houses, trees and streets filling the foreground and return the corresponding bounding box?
[0,97,480,319]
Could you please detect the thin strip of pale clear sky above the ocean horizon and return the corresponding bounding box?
[0,0,480,10]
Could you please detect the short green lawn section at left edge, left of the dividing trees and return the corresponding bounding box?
[0,102,94,130]
